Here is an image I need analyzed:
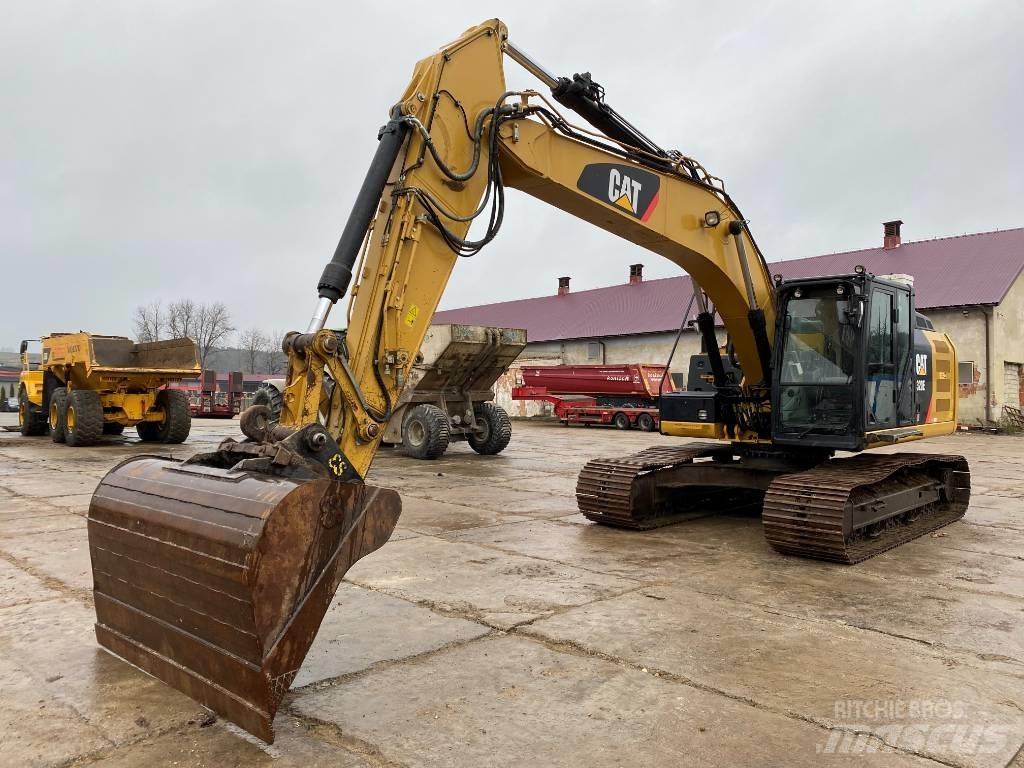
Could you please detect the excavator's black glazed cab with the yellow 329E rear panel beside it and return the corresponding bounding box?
[772,268,937,452]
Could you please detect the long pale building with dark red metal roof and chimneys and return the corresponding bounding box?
[433,221,1024,422]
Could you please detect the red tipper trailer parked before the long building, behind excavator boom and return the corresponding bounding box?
[512,362,675,432]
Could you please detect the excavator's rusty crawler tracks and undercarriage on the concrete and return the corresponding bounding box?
[577,442,971,563]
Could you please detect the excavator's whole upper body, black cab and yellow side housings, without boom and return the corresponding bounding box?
[660,267,942,455]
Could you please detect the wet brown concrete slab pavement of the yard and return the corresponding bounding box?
[0,414,1024,768]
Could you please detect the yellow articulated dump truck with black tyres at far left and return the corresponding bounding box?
[17,332,200,445]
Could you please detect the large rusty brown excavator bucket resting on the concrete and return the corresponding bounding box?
[88,457,401,742]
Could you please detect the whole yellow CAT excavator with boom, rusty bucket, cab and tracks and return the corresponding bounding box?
[88,19,970,741]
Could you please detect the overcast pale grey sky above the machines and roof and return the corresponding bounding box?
[0,0,1024,347]
